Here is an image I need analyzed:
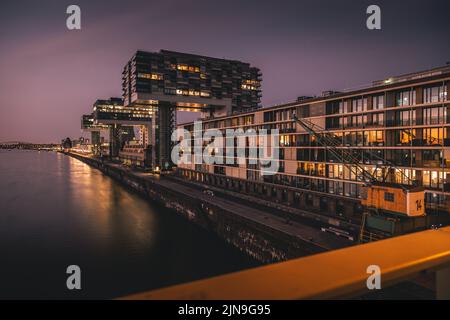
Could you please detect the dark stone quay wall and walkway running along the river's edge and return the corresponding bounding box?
[66,153,351,263]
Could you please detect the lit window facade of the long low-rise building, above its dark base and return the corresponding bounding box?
[178,72,450,211]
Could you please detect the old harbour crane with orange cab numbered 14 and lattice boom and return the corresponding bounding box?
[292,113,425,238]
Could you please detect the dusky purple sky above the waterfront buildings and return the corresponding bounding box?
[0,0,450,142]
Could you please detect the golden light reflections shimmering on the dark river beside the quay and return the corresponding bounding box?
[68,158,157,250]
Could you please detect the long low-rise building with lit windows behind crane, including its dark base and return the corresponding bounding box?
[177,66,450,240]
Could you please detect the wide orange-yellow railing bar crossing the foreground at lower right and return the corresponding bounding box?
[123,227,450,300]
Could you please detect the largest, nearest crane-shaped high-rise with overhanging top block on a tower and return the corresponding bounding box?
[122,50,262,168]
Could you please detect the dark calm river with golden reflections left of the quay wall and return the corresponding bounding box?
[0,150,257,299]
